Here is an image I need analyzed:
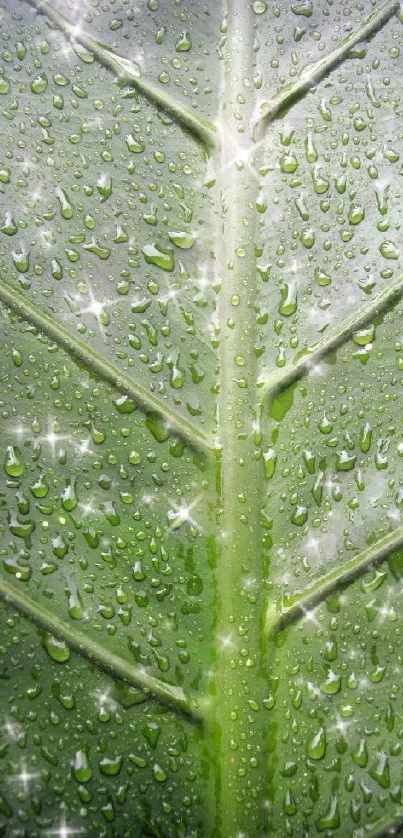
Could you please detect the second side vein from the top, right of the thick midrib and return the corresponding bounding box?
[261,277,403,398]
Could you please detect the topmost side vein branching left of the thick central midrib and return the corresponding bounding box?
[24,0,218,147]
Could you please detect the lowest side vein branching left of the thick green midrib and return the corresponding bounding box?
[0,579,201,719]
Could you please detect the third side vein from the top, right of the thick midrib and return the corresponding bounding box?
[266,527,403,635]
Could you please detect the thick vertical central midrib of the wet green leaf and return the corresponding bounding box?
[209,0,269,838]
